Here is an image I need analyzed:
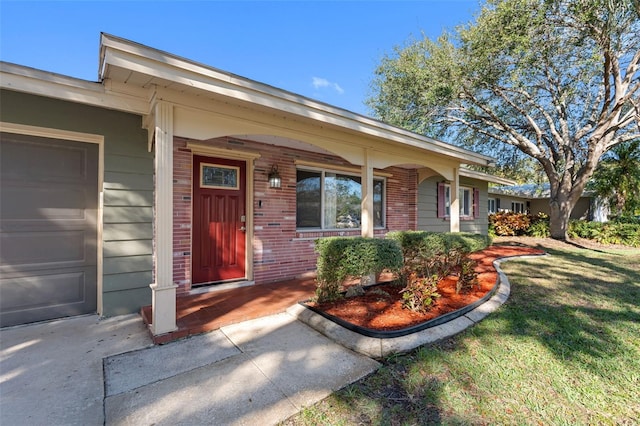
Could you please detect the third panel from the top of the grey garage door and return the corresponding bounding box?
[0,230,97,272]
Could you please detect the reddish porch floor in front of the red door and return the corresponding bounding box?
[140,278,316,344]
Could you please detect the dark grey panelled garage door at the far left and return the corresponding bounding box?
[0,133,98,327]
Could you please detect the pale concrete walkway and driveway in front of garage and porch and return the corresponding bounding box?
[0,314,379,425]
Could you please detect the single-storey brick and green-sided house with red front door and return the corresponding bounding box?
[0,34,504,335]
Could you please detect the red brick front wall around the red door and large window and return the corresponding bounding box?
[173,138,417,291]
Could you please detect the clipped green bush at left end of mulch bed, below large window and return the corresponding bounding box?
[315,237,402,302]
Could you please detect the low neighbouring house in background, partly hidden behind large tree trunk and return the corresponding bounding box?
[488,184,606,220]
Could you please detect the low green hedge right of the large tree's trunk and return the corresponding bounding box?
[567,220,640,247]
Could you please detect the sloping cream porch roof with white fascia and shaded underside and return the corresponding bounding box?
[99,33,493,166]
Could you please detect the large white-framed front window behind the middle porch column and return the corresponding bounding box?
[296,169,384,229]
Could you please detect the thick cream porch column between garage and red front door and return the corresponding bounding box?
[150,102,177,335]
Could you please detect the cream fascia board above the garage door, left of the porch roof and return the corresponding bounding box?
[0,62,149,115]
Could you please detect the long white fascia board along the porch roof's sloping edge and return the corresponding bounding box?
[100,34,493,166]
